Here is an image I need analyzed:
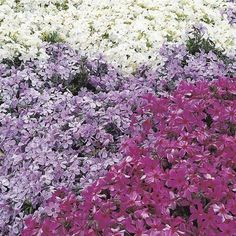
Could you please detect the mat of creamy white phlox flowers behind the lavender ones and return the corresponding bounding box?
[0,0,236,72]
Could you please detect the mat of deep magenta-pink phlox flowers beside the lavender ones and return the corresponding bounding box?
[22,77,236,236]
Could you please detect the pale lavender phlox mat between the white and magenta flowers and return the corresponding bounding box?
[0,37,235,234]
